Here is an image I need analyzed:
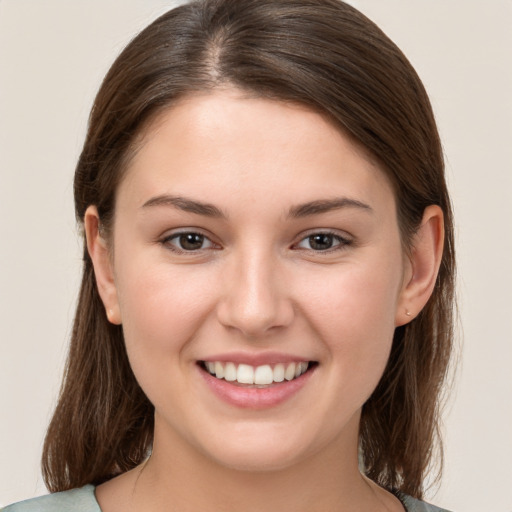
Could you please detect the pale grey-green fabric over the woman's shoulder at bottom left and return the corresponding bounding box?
[0,485,101,512]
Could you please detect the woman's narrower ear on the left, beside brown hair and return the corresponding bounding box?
[84,206,121,325]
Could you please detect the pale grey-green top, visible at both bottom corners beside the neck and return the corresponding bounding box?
[0,485,448,512]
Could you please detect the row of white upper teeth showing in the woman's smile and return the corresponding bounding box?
[205,361,309,386]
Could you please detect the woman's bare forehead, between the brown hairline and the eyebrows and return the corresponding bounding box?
[118,89,394,216]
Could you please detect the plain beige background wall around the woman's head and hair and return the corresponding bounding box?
[0,0,512,512]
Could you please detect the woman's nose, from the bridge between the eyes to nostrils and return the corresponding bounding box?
[217,251,294,338]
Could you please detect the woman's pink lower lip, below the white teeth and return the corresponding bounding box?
[198,365,316,409]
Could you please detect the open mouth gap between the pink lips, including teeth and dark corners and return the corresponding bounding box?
[198,361,318,388]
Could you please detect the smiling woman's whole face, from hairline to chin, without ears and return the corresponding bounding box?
[94,90,408,469]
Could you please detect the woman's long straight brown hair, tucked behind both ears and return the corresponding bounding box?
[42,0,455,497]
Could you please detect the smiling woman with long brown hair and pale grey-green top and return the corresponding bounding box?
[1,0,454,512]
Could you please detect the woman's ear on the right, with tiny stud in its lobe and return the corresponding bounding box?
[395,205,444,326]
